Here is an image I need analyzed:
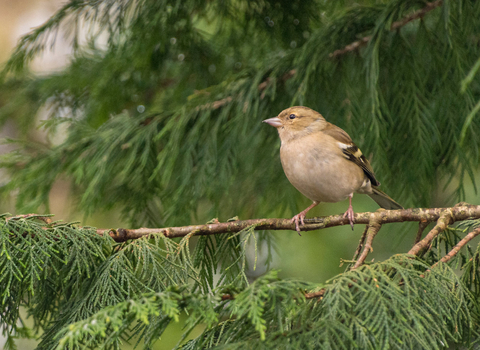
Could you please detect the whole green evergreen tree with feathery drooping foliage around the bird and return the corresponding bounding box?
[0,0,480,349]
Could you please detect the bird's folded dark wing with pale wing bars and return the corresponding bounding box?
[323,123,380,186]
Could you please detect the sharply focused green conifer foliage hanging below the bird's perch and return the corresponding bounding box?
[0,216,480,349]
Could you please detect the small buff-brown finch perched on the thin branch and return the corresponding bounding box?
[263,106,403,235]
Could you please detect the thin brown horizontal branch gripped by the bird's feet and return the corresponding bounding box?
[97,204,480,243]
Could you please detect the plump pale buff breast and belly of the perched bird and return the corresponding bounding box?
[280,135,365,202]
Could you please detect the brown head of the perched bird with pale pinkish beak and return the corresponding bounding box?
[263,106,327,142]
